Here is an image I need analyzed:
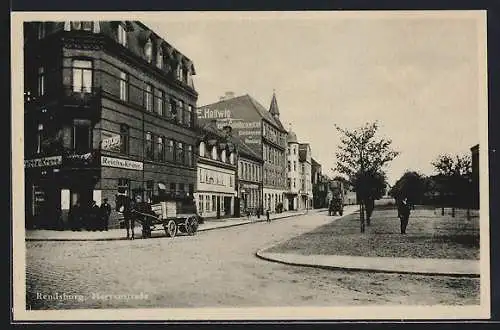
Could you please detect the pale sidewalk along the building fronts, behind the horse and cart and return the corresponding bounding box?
[25,210,306,241]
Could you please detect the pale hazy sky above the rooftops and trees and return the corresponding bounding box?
[141,12,482,184]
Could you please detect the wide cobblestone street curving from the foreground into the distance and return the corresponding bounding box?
[26,212,479,309]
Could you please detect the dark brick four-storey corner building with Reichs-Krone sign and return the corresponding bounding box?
[24,21,198,228]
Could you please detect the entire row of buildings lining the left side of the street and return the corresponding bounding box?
[24,21,315,227]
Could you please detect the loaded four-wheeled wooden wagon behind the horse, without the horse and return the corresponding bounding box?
[134,201,198,237]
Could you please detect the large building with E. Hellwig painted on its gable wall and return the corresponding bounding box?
[197,93,287,212]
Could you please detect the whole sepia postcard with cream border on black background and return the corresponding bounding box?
[11,11,490,321]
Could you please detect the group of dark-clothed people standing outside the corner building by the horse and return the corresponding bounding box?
[68,198,111,231]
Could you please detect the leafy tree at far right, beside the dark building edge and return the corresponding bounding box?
[431,154,472,216]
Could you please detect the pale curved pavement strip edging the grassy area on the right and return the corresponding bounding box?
[256,249,480,278]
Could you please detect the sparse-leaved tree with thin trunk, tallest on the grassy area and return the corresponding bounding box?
[335,122,399,233]
